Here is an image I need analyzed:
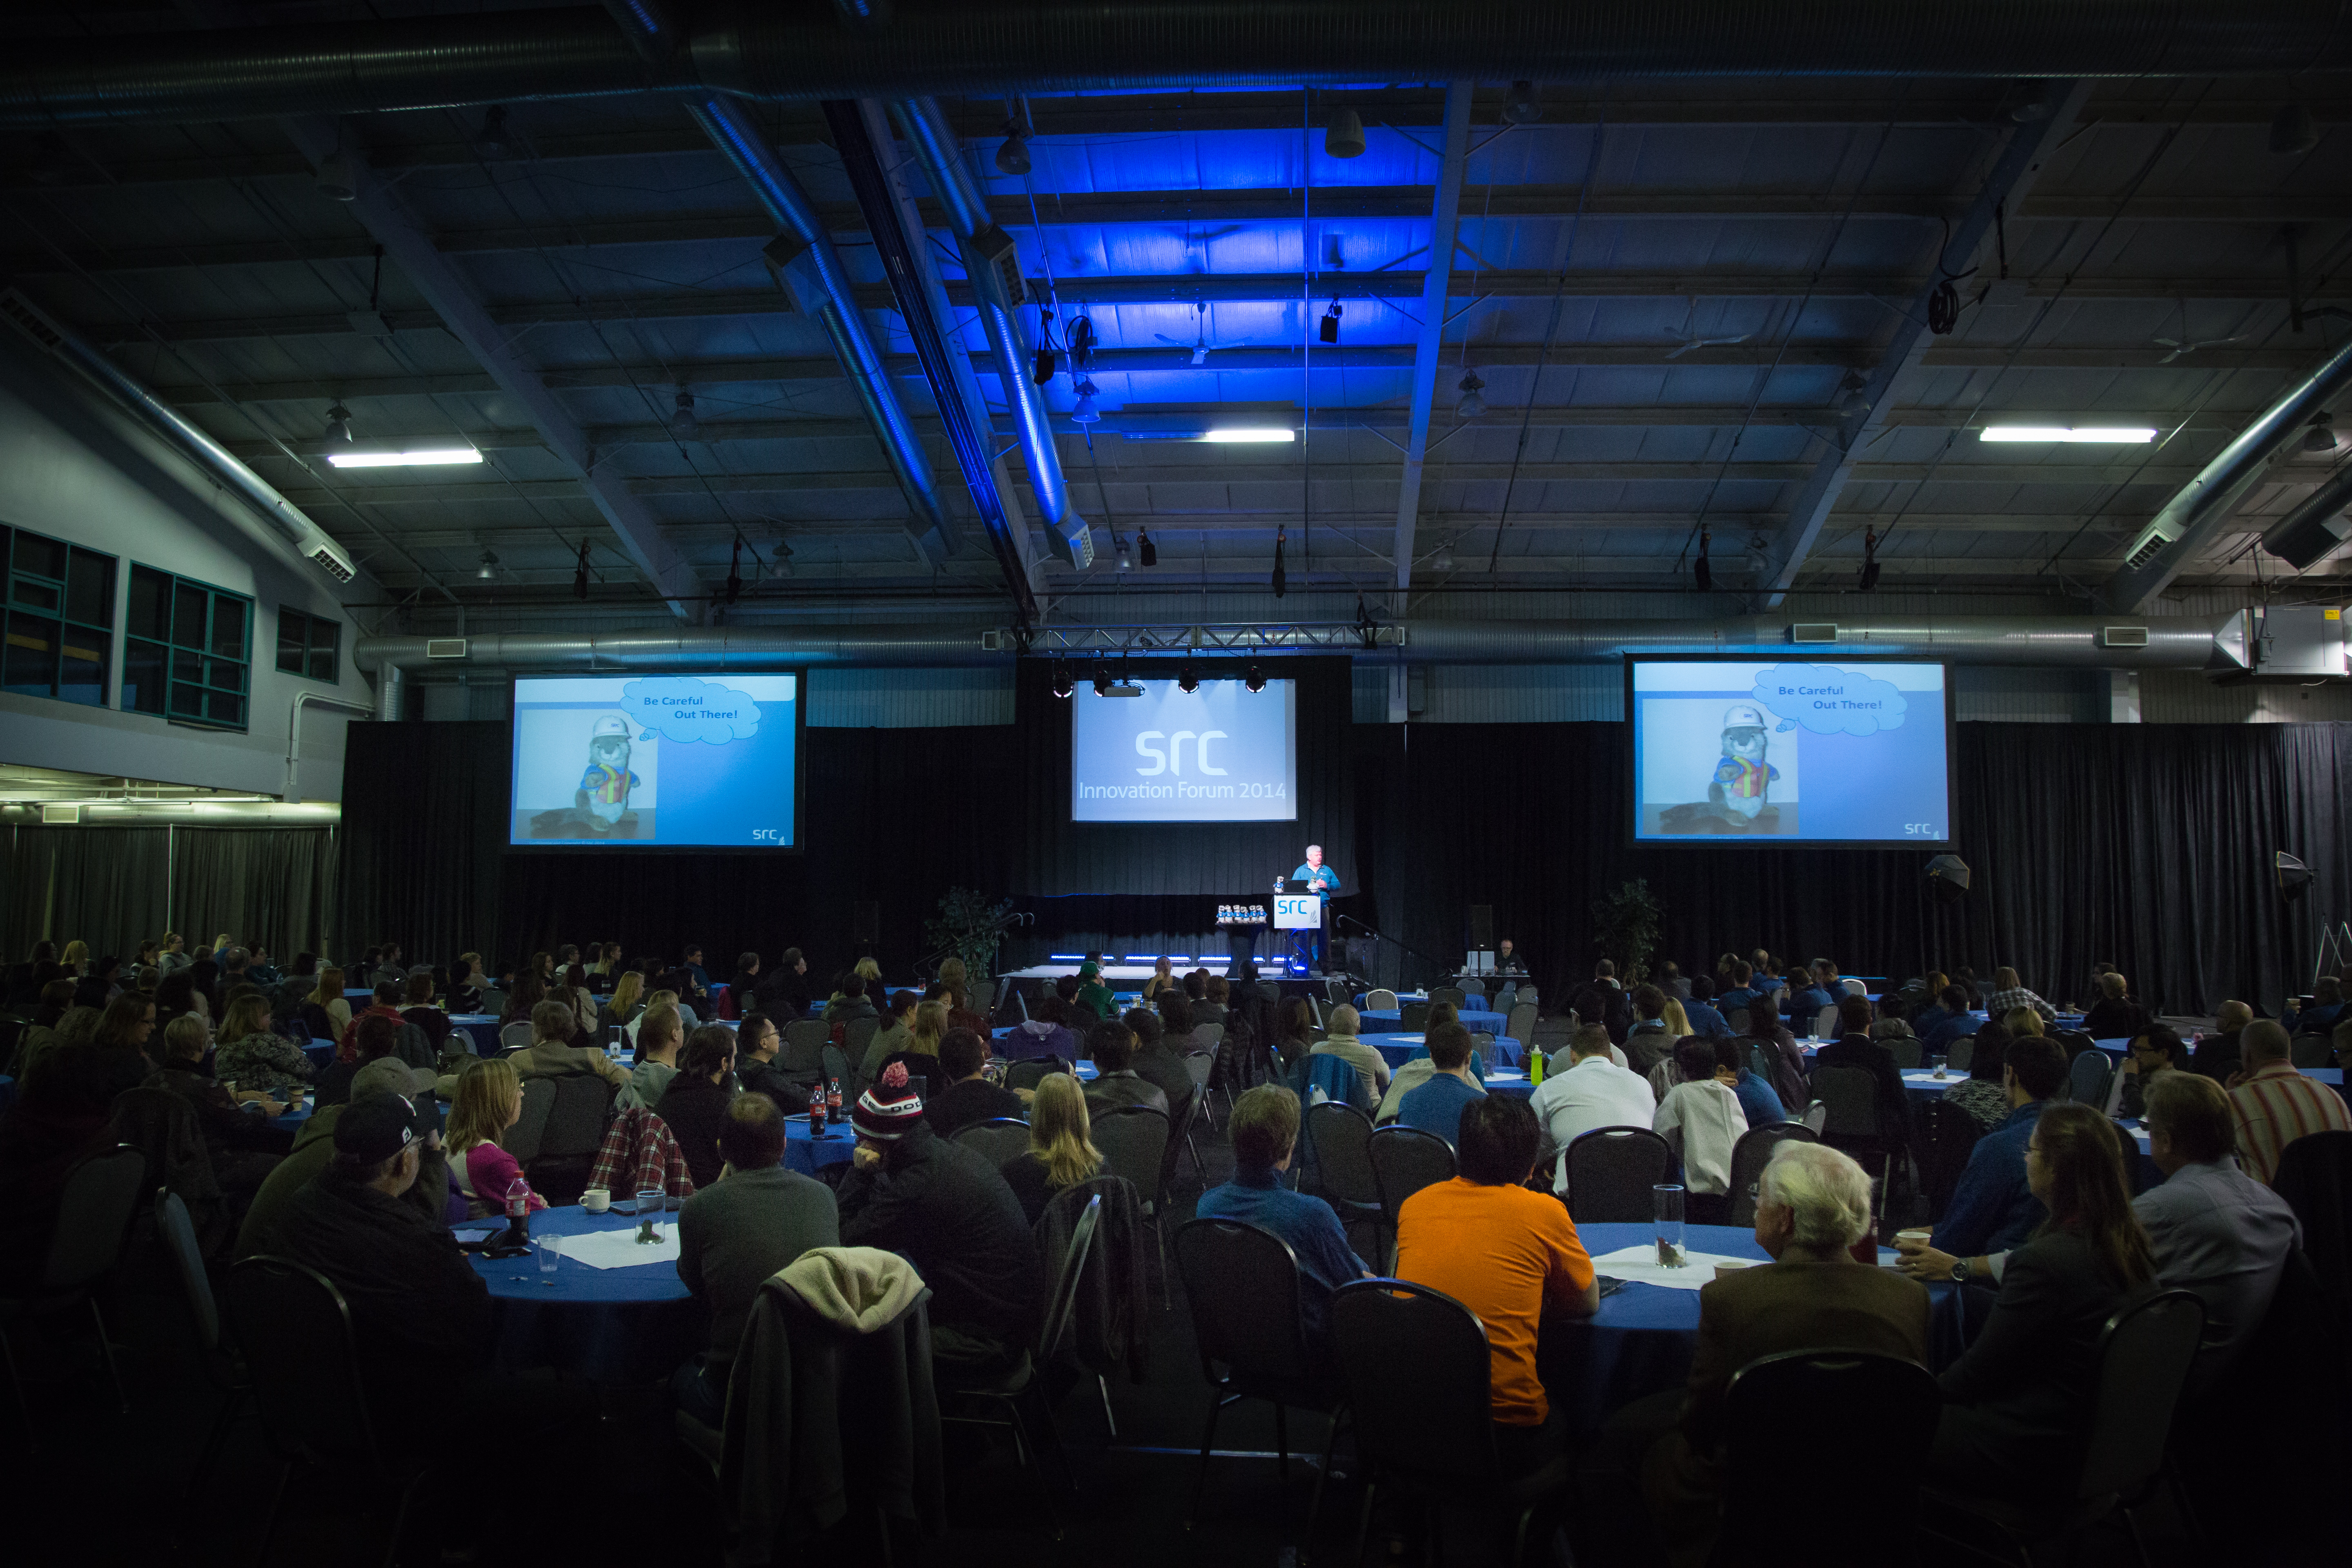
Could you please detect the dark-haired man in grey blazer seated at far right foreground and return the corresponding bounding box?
[2131,1072,2303,1387]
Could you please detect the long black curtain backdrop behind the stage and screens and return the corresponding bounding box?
[341,710,2352,1011]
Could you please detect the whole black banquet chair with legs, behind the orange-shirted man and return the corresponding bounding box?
[1331,1279,1571,1563]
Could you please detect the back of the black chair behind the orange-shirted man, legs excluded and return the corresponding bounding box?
[1329,1279,1496,1490]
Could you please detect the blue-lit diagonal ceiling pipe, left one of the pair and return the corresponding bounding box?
[604,0,957,562]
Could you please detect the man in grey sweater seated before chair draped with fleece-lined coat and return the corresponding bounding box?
[673,1096,842,1427]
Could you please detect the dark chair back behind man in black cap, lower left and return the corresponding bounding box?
[221,1253,381,1472]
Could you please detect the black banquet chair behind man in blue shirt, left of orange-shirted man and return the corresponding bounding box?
[1176,1220,1341,1542]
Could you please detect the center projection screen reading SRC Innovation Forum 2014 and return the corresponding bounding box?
[1070,679,1298,823]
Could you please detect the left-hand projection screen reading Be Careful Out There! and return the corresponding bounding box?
[508,673,804,849]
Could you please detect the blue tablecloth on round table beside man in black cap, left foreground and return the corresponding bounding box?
[459,1206,710,1382]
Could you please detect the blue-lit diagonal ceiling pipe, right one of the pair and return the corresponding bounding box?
[891,99,1094,569]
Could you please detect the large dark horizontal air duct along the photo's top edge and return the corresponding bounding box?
[0,0,2352,127]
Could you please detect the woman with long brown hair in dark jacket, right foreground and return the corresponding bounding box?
[1926,1105,2154,1502]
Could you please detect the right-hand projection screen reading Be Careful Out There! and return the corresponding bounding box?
[1625,658,1952,846]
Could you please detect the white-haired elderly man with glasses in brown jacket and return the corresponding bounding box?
[1637,1143,1929,1568]
